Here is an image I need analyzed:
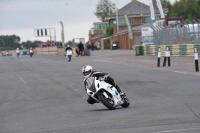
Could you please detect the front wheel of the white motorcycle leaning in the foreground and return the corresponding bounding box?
[99,94,115,110]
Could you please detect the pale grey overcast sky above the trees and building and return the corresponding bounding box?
[0,0,175,42]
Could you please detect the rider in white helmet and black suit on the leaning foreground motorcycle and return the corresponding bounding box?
[82,65,125,104]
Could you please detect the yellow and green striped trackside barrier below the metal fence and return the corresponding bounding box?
[134,44,200,56]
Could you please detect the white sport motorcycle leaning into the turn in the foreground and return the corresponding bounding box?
[85,77,130,110]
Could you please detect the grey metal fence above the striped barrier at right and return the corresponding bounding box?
[134,23,200,45]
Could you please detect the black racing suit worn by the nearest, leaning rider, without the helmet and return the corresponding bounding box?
[87,71,122,104]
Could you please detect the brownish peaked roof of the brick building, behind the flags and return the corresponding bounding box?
[111,0,167,16]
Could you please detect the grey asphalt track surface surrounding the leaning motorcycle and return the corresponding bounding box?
[0,50,200,133]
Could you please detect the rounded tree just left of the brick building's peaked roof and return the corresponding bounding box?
[94,0,115,22]
